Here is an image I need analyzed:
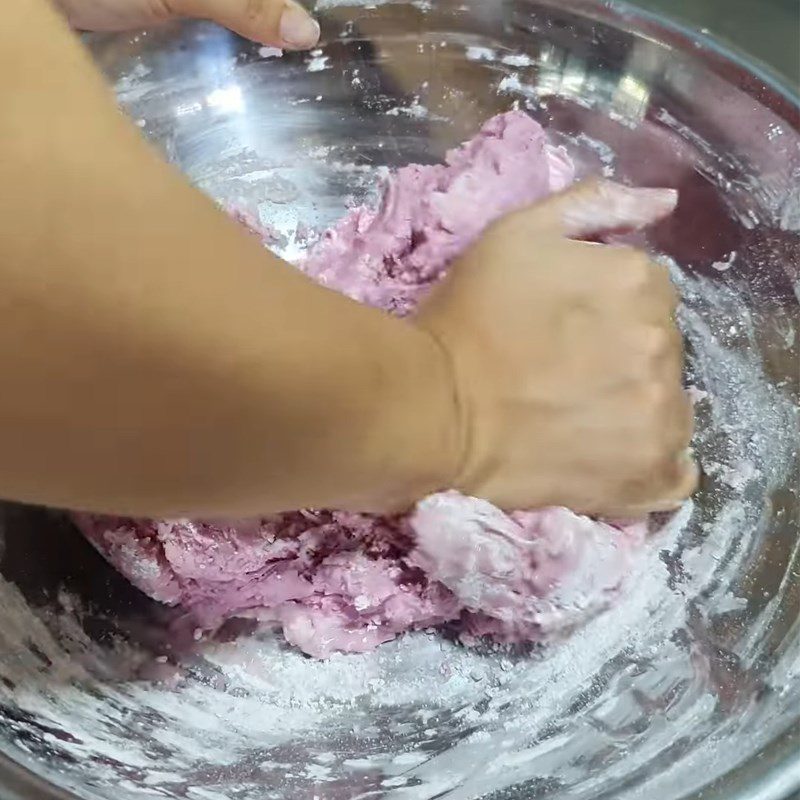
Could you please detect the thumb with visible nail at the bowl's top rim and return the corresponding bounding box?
[169,0,319,50]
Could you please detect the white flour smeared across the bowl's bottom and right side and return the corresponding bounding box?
[0,258,796,800]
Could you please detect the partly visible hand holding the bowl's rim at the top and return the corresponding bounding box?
[56,0,319,50]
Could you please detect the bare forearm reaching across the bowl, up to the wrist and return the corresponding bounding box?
[0,0,455,515]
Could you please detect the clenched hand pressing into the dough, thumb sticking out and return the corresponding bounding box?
[417,182,696,516]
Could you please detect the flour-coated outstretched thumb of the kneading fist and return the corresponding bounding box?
[534,179,678,239]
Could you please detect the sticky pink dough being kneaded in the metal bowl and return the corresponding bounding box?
[77,112,645,658]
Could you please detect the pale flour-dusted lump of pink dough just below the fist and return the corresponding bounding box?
[408,492,647,642]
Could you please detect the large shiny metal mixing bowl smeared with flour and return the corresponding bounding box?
[0,0,800,800]
